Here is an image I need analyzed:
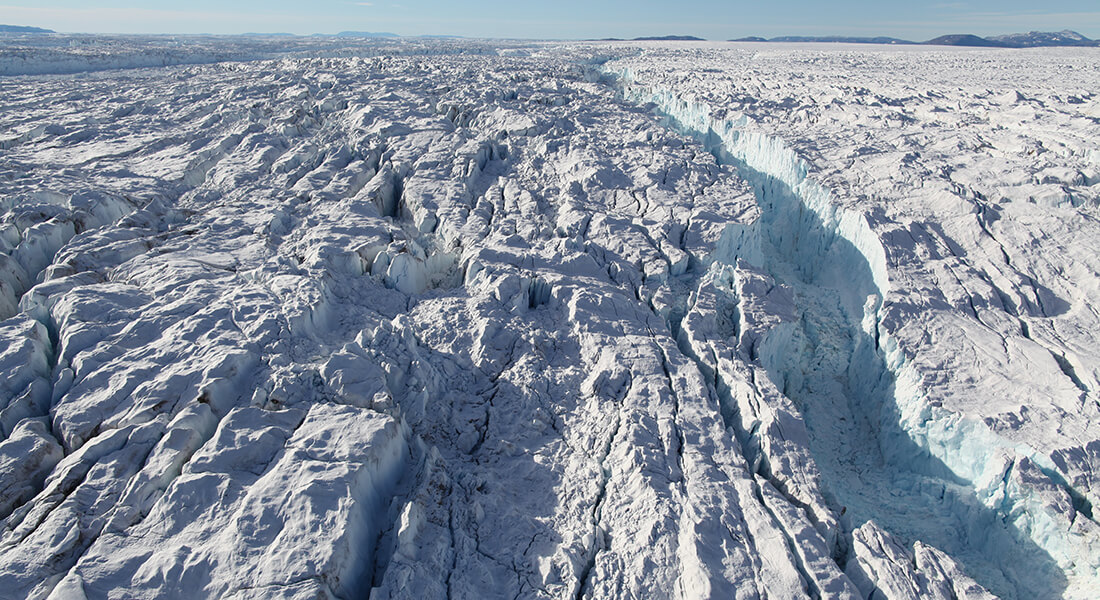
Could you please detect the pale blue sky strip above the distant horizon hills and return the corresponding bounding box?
[0,0,1100,40]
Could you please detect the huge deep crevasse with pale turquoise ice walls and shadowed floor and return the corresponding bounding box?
[602,67,1100,598]
